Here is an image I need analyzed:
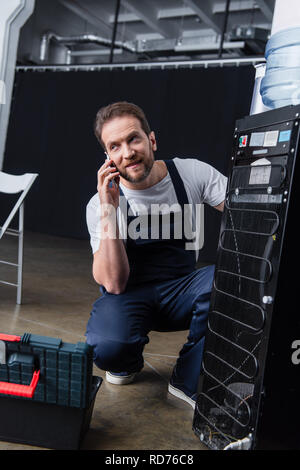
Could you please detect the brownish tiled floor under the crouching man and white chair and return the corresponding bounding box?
[0,232,206,450]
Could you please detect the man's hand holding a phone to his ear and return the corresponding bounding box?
[97,160,120,209]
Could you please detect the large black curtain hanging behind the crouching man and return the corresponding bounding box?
[3,66,255,262]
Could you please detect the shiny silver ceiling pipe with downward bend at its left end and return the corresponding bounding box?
[40,31,136,62]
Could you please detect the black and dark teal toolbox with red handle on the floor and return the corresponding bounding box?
[0,333,102,450]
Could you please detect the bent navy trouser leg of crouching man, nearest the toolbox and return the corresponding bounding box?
[86,282,154,373]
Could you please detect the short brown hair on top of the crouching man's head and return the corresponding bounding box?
[94,101,151,150]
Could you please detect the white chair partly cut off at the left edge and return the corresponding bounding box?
[0,171,38,304]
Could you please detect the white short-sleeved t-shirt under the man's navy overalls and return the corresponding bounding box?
[86,157,227,253]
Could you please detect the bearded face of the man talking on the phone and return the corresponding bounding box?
[101,115,156,183]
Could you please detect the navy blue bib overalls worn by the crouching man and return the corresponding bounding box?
[86,160,214,396]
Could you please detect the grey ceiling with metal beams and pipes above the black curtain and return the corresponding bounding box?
[18,0,275,66]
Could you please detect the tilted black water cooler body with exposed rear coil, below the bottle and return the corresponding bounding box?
[193,106,300,449]
